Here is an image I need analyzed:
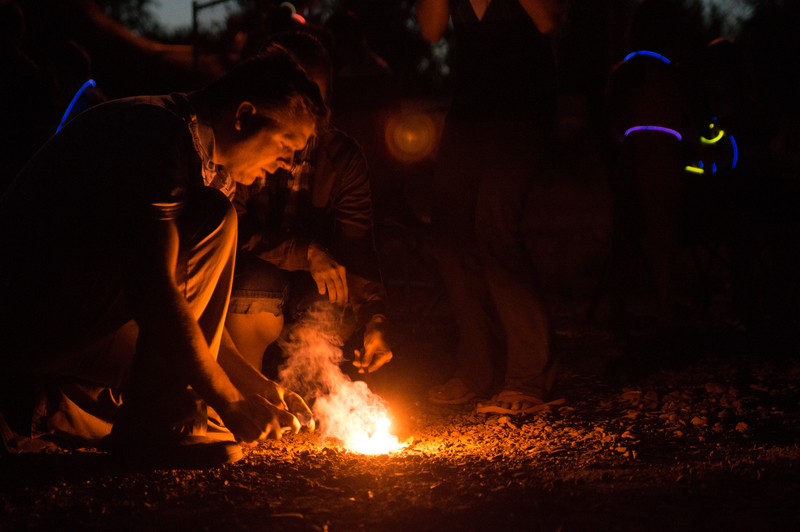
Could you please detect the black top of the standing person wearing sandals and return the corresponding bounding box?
[450,0,556,127]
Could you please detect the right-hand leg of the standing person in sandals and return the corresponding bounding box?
[475,123,554,403]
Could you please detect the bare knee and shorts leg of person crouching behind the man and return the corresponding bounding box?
[225,251,289,371]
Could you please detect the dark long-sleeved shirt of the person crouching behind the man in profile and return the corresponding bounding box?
[233,129,386,324]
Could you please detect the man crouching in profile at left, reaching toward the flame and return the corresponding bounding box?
[0,48,327,468]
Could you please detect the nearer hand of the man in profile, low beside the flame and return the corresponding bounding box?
[219,395,300,444]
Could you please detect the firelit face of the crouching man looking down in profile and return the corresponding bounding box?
[224,114,314,185]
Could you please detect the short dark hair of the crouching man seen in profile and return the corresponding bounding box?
[203,49,328,129]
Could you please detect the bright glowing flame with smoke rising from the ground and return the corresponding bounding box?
[280,305,405,454]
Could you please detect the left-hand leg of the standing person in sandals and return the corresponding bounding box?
[429,119,501,402]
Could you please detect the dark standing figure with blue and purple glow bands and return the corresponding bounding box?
[605,0,698,340]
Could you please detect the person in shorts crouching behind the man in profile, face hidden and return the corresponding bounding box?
[226,32,393,375]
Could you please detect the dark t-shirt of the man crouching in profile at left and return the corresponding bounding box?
[0,94,203,284]
